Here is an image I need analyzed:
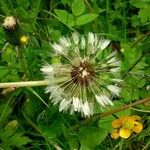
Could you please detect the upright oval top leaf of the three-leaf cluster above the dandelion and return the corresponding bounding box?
[71,0,85,16]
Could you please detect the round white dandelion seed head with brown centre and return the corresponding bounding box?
[41,32,122,117]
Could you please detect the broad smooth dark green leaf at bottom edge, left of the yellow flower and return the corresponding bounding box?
[79,127,108,150]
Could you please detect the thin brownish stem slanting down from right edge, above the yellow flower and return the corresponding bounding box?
[69,97,150,131]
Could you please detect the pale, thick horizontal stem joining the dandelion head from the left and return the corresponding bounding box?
[0,80,49,88]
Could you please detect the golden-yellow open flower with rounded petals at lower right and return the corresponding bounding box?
[111,115,143,139]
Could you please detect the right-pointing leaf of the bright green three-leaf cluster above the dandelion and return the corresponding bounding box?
[76,14,98,25]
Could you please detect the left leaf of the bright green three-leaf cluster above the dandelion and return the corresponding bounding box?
[54,9,74,27]
